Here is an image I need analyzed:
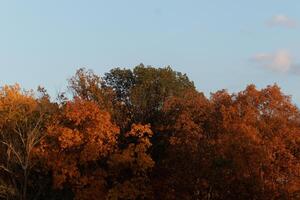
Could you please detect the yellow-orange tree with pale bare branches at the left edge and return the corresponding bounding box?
[0,85,44,200]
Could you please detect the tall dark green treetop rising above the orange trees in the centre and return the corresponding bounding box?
[104,64,195,125]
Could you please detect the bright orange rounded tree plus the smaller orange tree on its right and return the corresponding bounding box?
[36,97,154,199]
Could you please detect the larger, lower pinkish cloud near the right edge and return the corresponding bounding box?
[251,49,300,73]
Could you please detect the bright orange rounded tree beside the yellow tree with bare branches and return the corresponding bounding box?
[40,98,119,199]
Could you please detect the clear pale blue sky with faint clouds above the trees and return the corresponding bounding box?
[0,0,300,105]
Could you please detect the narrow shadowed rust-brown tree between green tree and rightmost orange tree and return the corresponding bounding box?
[153,90,210,199]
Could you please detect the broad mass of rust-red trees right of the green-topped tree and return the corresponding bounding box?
[153,85,300,199]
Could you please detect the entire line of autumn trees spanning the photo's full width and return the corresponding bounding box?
[0,65,300,200]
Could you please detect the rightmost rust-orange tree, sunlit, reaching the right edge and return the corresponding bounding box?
[209,85,300,199]
